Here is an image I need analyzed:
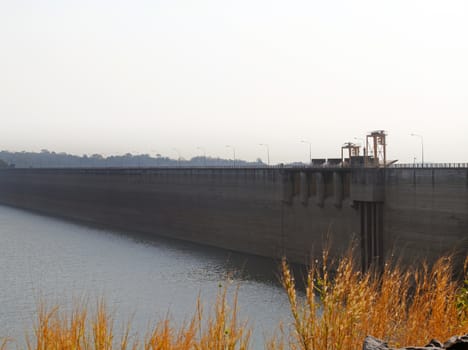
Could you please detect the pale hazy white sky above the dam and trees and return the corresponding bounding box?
[0,0,468,162]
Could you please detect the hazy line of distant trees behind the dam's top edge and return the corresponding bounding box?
[0,150,274,168]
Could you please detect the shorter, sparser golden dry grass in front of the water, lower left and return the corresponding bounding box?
[22,288,250,350]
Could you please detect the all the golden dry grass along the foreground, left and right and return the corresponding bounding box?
[4,250,468,350]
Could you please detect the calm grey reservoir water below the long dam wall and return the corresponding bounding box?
[0,206,289,349]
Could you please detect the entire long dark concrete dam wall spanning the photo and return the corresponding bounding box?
[0,165,468,266]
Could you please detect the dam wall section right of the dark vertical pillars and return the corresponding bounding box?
[383,167,468,266]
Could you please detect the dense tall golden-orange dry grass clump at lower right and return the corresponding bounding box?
[280,249,468,350]
